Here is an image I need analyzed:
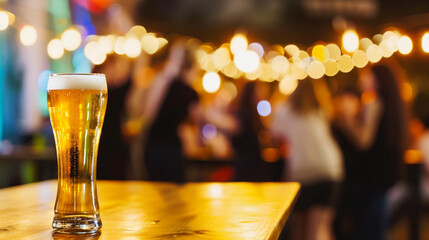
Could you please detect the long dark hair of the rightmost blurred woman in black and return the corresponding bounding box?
[371,65,408,151]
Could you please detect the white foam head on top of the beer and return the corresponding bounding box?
[48,74,107,90]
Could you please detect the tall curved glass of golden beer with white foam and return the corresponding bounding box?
[47,74,107,234]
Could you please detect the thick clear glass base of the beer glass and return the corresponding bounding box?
[52,215,101,234]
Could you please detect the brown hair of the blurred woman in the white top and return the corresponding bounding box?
[288,78,320,114]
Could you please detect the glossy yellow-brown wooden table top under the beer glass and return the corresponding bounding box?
[0,180,299,240]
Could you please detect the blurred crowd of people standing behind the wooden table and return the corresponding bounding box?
[94,38,429,239]
